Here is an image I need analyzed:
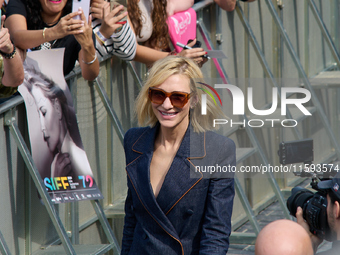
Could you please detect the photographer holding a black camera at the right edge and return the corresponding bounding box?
[296,174,340,255]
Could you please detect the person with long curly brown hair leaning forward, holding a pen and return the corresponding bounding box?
[127,0,207,66]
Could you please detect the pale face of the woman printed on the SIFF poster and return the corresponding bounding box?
[31,86,61,154]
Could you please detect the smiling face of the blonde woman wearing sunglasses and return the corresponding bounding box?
[151,74,191,130]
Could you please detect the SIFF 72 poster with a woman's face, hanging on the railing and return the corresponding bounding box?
[18,49,103,203]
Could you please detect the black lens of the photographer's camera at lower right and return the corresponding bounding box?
[287,187,314,217]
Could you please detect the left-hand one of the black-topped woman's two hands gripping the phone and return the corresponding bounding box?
[45,10,86,41]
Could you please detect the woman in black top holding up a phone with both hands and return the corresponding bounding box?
[5,0,99,80]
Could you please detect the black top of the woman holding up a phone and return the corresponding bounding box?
[6,0,96,75]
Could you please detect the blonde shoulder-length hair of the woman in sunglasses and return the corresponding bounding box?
[135,56,225,132]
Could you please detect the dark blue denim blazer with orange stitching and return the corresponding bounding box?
[122,125,236,255]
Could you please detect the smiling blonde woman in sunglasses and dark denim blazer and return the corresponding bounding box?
[121,56,236,255]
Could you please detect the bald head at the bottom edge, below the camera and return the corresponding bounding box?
[255,220,314,255]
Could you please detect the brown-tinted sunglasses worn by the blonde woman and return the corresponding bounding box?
[149,88,191,108]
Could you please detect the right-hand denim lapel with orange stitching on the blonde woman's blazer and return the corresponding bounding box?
[157,125,205,214]
